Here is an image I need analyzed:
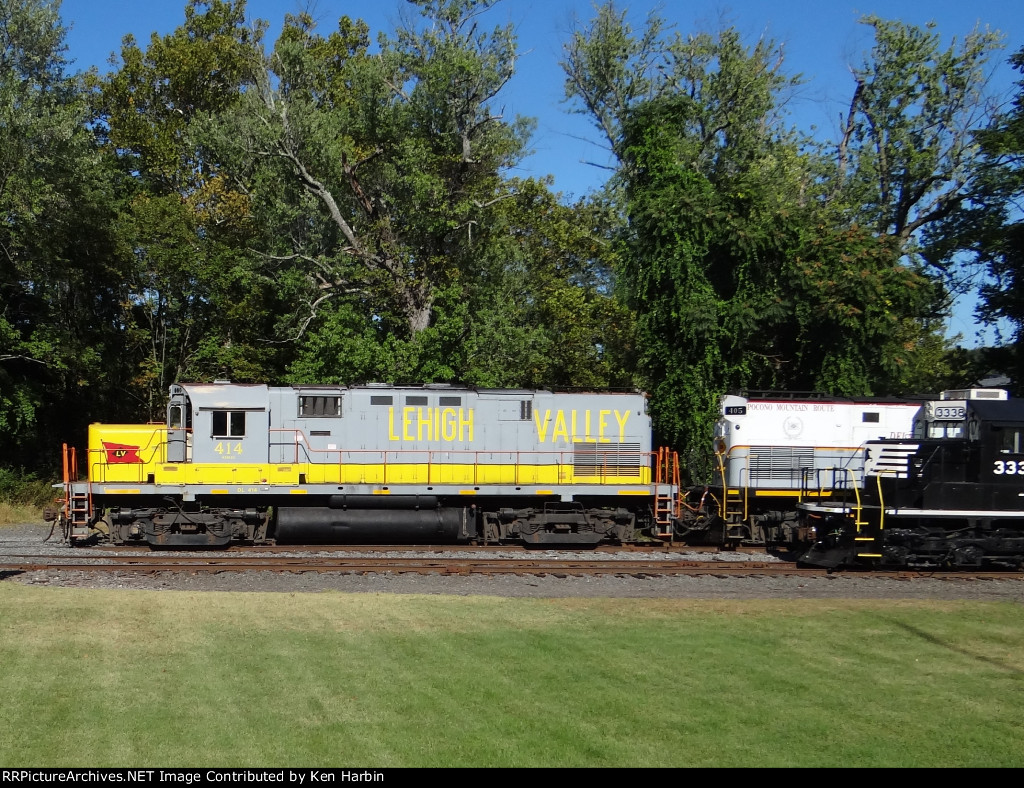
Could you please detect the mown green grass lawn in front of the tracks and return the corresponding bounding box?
[0,582,1024,768]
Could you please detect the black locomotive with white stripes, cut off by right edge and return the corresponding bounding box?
[798,399,1024,569]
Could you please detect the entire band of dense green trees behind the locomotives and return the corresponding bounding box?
[0,0,1024,478]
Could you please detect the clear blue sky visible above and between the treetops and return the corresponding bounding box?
[54,0,1024,344]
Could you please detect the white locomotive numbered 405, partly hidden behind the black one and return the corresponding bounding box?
[680,389,1007,545]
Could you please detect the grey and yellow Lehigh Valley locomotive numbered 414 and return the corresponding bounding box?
[56,382,680,546]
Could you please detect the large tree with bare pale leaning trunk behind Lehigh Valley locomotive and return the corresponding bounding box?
[203,0,529,378]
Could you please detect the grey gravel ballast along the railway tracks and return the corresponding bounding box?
[0,524,1024,604]
